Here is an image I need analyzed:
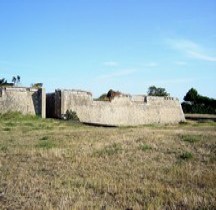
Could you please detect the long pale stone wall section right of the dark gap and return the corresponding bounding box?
[55,90,185,126]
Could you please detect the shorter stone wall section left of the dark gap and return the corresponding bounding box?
[0,87,46,118]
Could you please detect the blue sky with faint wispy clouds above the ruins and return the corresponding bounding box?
[0,0,216,100]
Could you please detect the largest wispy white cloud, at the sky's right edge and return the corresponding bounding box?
[167,39,216,62]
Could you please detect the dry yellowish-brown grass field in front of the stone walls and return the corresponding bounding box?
[0,114,216,210]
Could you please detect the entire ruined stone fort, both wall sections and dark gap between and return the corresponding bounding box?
[0,87,185,126]
